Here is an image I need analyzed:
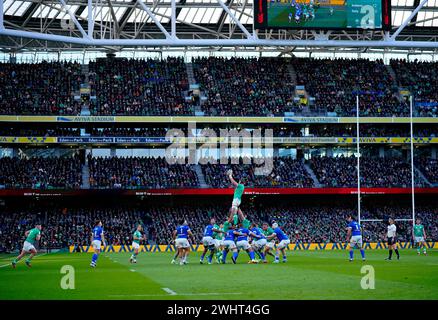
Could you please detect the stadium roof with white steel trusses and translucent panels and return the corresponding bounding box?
[0,0,438,52]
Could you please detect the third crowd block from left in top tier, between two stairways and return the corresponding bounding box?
[193,57,302,116]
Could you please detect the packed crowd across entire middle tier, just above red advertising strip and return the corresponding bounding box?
[0,154,438,189]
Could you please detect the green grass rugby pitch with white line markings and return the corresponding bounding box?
[0,250,438,300]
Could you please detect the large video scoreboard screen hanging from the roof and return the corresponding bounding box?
[254,0,391,30]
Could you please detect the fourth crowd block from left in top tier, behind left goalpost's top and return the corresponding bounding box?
[292,58,409,117]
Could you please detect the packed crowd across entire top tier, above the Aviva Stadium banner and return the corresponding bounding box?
[0,57,438,117]
